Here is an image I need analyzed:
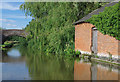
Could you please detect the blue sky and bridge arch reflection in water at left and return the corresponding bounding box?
[2,48,31,80]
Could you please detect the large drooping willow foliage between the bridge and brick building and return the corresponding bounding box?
[20,2,107,54]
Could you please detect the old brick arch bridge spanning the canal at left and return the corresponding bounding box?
[0,29,28,42]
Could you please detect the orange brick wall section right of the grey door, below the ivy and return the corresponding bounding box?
[98,31,120,55]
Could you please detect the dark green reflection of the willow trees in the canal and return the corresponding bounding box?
[20,48,74,80]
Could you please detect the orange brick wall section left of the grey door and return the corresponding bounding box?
[75,23,94,52]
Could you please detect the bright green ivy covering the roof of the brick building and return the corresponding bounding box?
[86,2,120,40]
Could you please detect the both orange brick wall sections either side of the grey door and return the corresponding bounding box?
[75,23,120,55]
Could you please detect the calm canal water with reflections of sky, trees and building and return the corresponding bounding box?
[0,47,120,80]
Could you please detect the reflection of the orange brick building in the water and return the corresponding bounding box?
[74,61,120,80]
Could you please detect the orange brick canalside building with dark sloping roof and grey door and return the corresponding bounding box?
[74,2,120,58]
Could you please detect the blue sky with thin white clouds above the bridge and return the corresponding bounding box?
[0,2,32,29]
